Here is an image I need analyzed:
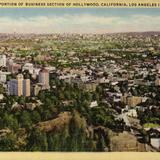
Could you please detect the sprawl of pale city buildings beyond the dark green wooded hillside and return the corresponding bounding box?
[0,34,160,149]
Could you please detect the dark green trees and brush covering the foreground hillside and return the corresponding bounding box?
[0,80,123,151]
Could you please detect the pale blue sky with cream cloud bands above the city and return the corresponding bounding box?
[0,8,160,34]
